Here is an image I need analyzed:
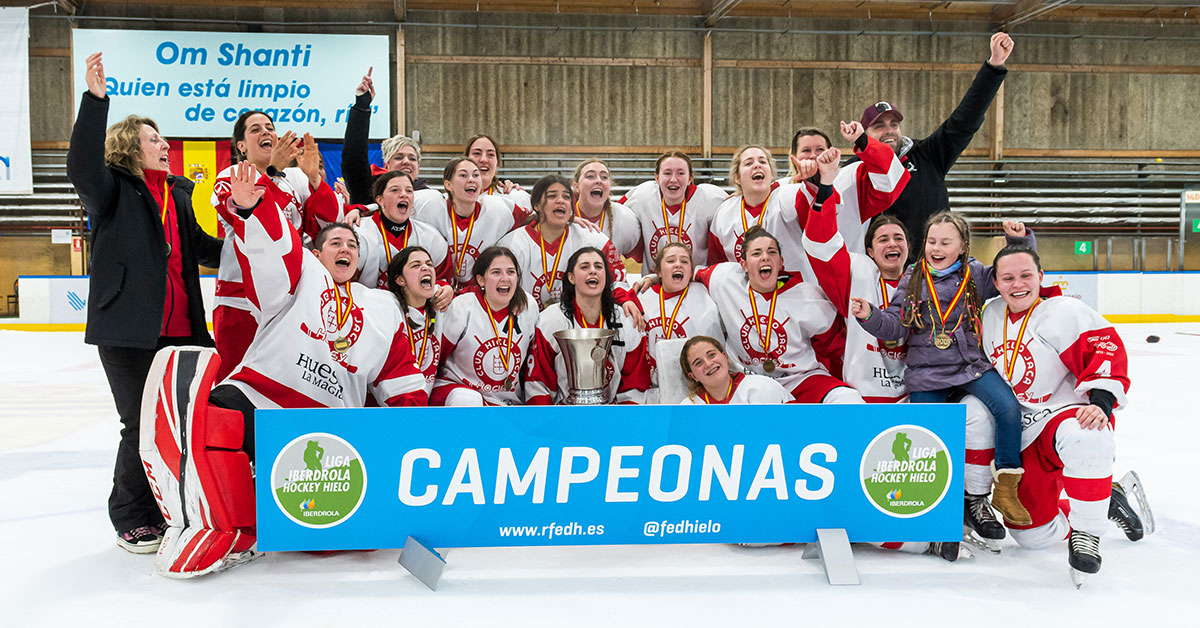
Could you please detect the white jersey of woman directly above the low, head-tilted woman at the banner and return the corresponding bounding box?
[696,262,844,395]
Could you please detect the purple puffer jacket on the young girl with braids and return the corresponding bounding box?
[858,228,1037,390]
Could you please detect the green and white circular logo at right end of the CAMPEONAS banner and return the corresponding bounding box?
[860,425,954,519]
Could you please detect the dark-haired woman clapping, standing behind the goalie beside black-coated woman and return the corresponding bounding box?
[211,110,346,378]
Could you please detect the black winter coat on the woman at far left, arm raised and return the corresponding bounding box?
[67,92,222,349]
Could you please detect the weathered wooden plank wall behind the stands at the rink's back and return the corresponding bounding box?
[30,9,1200,155]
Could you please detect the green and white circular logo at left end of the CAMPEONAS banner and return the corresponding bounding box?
[271,433,367,528]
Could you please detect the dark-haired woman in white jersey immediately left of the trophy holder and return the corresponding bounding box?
[430,248,538,406]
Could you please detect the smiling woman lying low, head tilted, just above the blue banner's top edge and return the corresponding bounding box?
[679,336,794,406]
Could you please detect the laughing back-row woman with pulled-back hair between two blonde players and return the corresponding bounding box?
[620,150,728,273]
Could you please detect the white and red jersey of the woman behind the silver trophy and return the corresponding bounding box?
[526,305,650,405]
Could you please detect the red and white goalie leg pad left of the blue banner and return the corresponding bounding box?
[139,347,254,578]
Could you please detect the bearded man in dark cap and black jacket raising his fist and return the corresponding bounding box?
[859,32,1013,262]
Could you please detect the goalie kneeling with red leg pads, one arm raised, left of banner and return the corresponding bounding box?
[139,162,426,578]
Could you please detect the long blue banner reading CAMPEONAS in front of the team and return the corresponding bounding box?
[256,405,965,551]
